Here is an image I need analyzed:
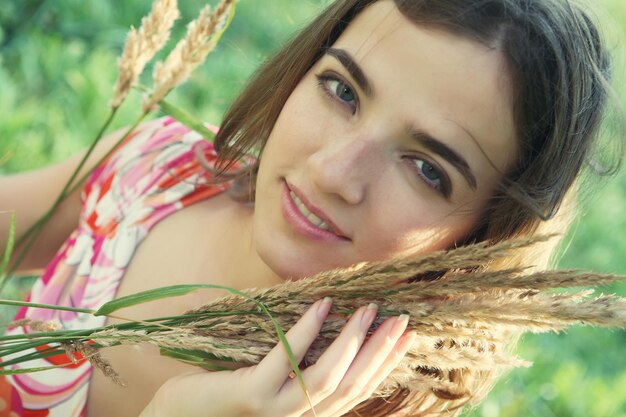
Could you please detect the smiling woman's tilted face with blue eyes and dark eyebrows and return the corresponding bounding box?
[253,0,516,279]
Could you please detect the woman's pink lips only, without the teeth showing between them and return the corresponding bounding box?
[282,181,349,241]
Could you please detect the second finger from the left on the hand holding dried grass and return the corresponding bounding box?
[281,304,378,412]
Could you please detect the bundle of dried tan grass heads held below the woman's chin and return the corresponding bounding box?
[0,236,626,402]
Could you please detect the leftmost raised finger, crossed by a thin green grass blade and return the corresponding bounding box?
[253,297,332,392]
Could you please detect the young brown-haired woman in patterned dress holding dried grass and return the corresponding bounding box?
[0,0,610,417]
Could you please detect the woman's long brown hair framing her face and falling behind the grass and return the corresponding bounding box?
[215,0,620,417]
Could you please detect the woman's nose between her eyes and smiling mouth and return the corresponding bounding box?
[308,139,384,204]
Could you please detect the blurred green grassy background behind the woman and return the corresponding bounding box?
[0,0,626,417]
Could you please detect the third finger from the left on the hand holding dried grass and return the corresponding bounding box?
[305,315,408,417]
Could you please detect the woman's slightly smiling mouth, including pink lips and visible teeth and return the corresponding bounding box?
[282,182,349,241]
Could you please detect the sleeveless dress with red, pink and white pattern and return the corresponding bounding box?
[0,118,227,417]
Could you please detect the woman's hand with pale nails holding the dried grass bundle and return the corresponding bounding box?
[141,299,415,417]
